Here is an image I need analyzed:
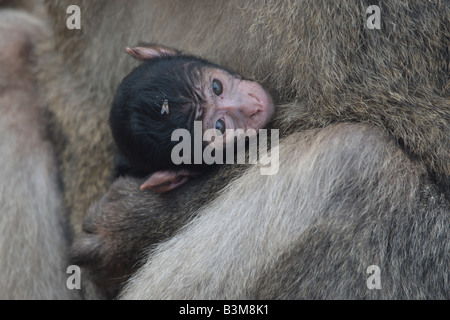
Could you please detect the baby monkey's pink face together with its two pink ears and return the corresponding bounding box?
[127,45,274,193]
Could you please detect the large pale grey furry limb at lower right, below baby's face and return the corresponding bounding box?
[121,124,450,299]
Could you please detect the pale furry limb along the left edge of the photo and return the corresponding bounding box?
[0,9,76,299]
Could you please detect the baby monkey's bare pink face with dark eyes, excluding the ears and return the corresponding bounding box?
[200,68,274,144]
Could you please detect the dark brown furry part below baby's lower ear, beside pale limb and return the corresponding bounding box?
[70,166,244,298]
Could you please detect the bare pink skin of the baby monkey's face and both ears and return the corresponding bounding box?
[126,45,275,194]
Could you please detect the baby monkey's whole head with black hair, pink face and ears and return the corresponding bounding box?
[110,45,274,193]
